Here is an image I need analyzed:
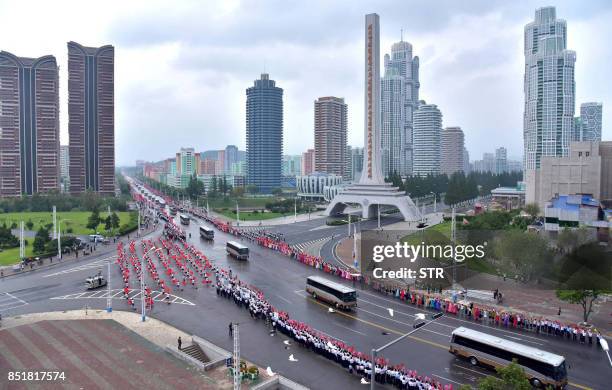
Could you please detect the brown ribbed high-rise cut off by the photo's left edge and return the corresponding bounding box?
[0,51,60,196]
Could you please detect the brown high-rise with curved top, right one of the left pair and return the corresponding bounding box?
[68,42,115,194]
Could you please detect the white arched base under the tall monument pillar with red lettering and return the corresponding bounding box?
[325,183,421,221]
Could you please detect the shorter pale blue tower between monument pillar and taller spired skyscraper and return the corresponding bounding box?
[380,68,406,177]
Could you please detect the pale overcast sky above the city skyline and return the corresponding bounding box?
[0,0,612,165]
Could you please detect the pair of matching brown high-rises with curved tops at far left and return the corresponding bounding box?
[0,42,115,197]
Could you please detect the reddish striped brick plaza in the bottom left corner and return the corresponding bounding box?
[0,320,217,390]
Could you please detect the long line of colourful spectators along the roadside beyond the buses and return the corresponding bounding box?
[192,206,602,345]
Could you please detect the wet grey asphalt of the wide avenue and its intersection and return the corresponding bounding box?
[0,216,611,389]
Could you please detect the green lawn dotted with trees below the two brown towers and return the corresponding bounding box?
[0,211,130,236]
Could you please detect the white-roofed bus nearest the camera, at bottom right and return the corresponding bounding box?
[450,327,567,389]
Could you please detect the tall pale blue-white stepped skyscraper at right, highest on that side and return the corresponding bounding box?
[523,7,576,173]
